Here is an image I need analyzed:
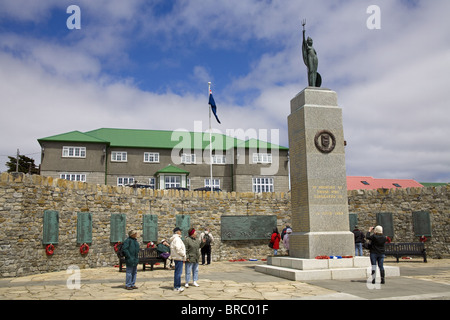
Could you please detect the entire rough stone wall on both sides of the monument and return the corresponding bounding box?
[0,173,450,277]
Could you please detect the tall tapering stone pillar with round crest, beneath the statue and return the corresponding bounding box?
[288,87,354,259]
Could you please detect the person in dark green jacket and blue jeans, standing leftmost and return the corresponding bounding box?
[122,230,139,290]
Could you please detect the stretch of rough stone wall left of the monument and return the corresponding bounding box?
[0,173,290,277]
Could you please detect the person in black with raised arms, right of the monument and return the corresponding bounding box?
[366,226,388,284]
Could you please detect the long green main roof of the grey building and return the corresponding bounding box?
[38,128,288,150]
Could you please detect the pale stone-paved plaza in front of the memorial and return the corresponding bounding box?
[0,258,450,301]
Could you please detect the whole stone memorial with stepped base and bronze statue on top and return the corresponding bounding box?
[256,20,400,280]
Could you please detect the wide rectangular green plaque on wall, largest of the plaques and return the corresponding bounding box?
[221,216,277,240]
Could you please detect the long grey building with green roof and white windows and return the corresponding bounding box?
[38,128,289,192]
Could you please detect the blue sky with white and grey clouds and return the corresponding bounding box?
[0,0,450,182]
